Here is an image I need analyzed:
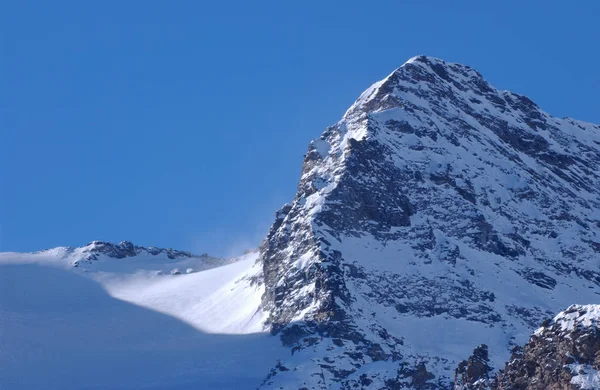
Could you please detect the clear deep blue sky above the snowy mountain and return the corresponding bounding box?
[0,0,600,255]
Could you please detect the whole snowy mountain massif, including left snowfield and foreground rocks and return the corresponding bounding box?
[0,56,600,390]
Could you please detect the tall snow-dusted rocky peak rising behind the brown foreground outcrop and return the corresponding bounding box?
[260,56,600,389]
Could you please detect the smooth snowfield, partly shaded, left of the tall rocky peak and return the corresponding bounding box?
[0,242,285,390]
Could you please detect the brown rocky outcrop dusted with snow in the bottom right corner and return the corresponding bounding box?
[491,305,600,390]
